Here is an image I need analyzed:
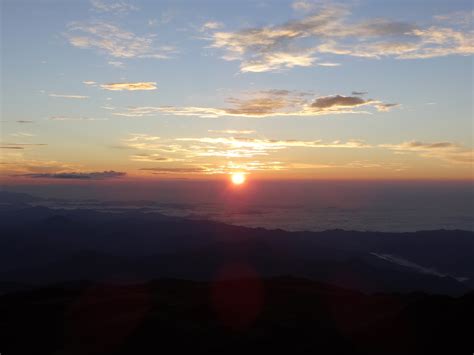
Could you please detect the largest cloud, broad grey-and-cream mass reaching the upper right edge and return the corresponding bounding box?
[209,1,474,73]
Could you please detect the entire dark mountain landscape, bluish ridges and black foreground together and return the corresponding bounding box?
[0,192,474,355]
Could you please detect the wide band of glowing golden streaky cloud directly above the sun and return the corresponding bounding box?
[119,134,472,175]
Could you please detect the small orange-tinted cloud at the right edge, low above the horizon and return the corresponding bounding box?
[380,141,474,164]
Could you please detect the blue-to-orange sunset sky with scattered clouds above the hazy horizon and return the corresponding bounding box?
[0,0,474,185]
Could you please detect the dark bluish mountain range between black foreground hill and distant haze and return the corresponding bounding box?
[0,195,474,295]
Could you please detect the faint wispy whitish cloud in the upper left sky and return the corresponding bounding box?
[66,21,175,59]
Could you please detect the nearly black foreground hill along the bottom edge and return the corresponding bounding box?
[0,277,474,355]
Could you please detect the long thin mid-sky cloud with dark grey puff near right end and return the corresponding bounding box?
[113,90,397,118]
